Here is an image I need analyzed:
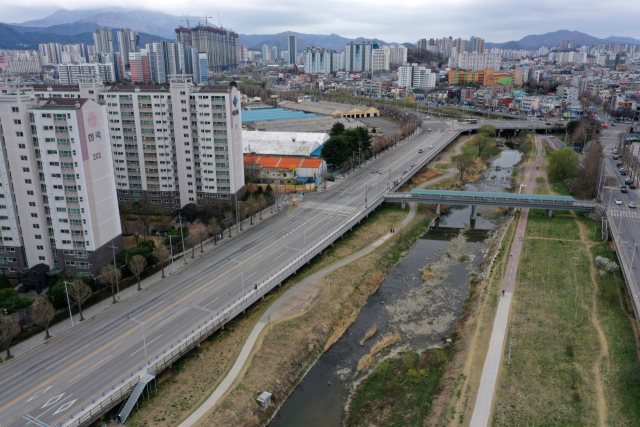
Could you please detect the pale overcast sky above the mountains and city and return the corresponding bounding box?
[0,0,640,43]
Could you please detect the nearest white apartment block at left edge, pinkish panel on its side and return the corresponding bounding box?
[0,87,122,278]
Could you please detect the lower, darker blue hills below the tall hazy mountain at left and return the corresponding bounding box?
[0,23,165,51]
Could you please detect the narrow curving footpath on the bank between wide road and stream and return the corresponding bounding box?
[179,203,416,427]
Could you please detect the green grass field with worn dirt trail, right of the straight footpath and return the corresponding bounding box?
[491,213,640,427]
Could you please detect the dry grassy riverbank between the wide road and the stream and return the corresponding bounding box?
[119,204,432,427]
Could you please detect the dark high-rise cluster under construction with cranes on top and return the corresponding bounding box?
[176,25,238,72]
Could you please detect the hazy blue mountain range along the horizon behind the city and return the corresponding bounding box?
[0,7,640,52]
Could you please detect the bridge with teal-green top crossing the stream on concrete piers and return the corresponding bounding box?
[384,190,596,219]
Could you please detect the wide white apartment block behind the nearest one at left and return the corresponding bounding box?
[34,76,244,213]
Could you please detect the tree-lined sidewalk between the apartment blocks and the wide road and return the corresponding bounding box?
[5,205,285,363]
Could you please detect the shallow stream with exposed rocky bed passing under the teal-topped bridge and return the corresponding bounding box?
[269,150,521,427]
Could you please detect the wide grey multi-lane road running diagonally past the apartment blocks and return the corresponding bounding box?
[0,117,478,427]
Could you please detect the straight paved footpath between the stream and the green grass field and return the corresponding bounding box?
[469,137,543,427]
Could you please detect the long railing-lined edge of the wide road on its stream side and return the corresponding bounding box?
[51,189,388,427]
